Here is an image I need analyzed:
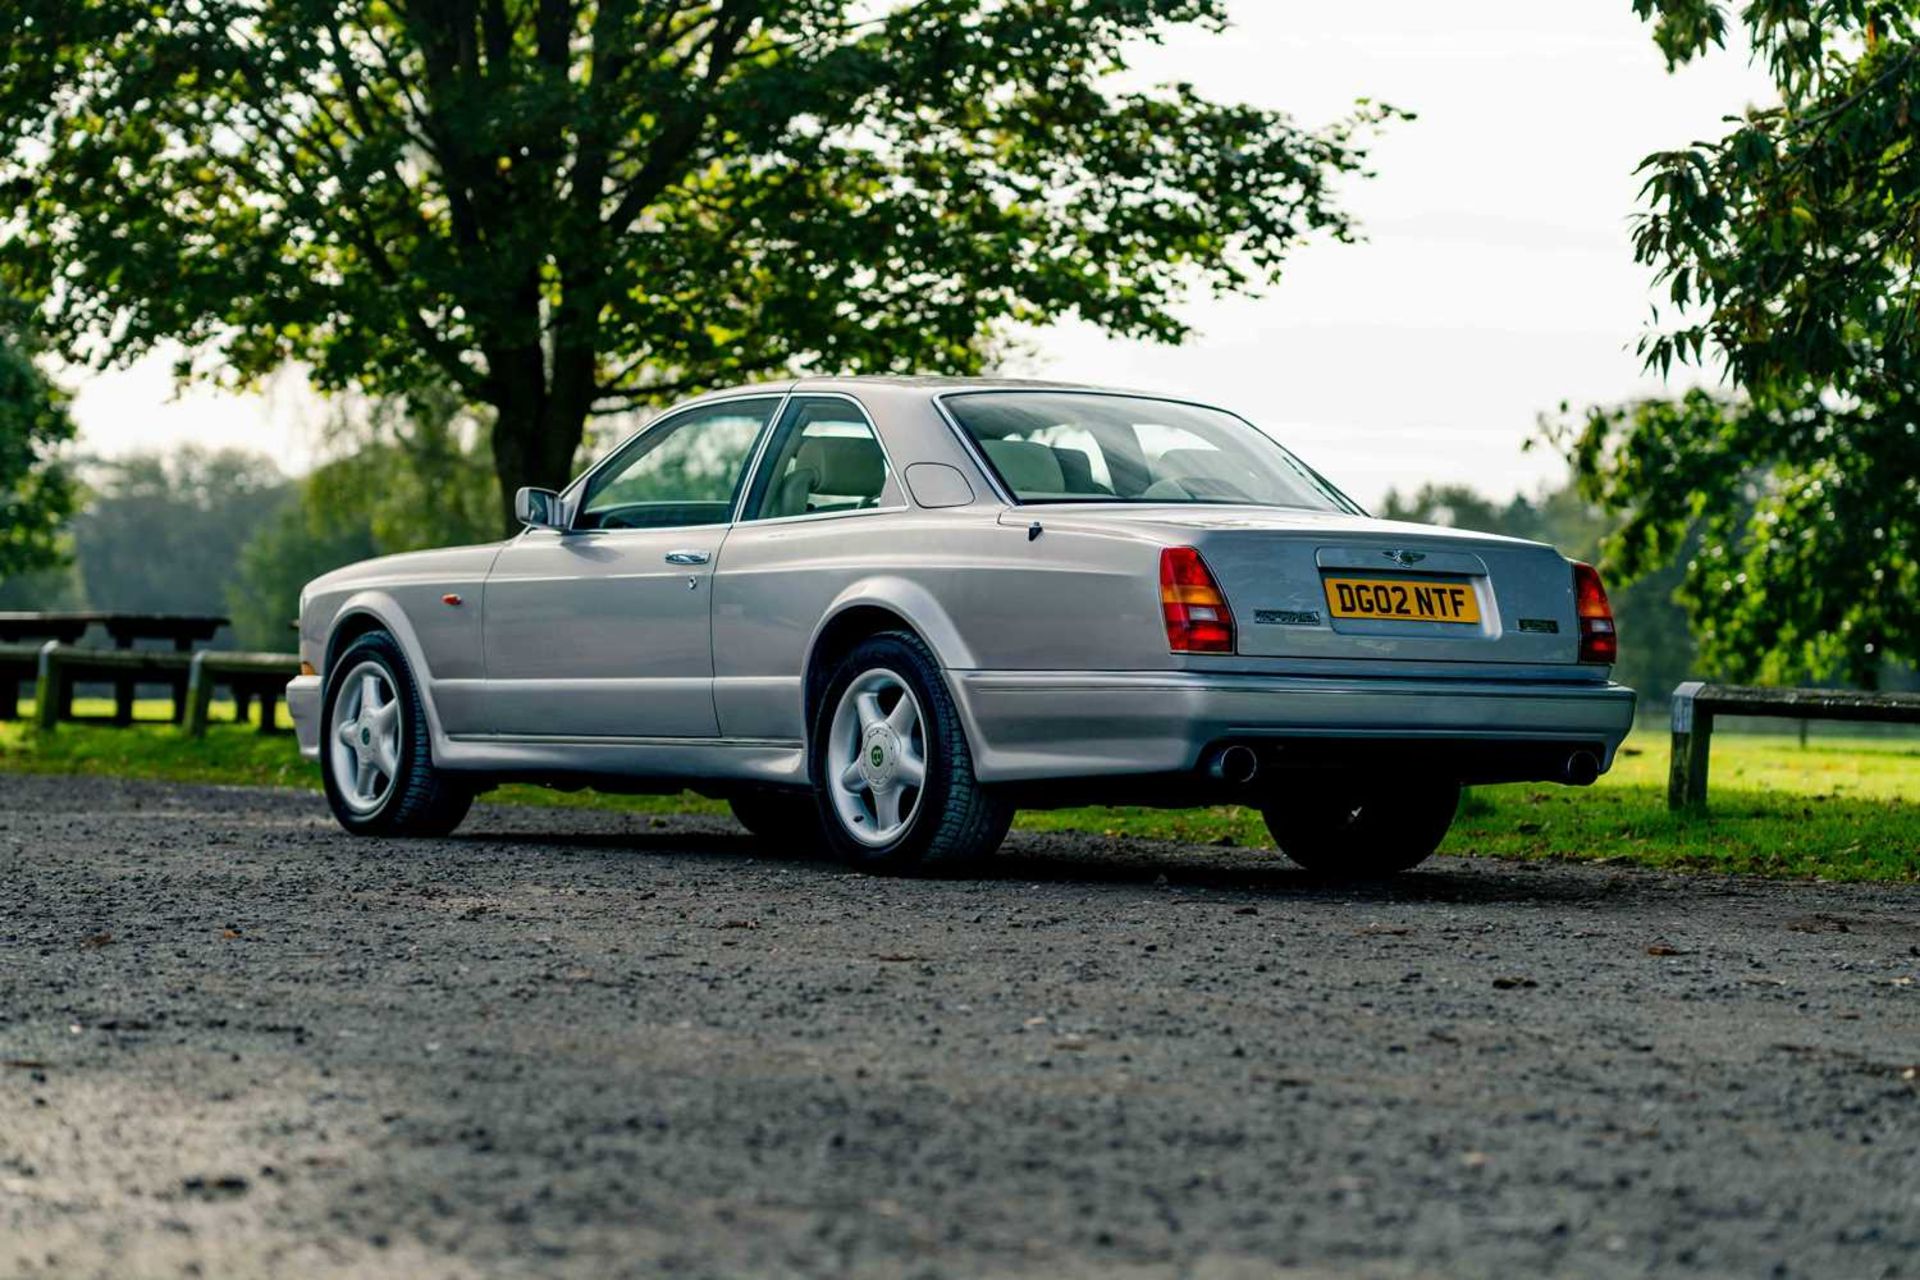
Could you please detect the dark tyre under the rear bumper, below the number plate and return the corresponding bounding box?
[1260,773,1459,879]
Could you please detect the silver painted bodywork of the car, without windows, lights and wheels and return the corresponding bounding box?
[288,378,1634,785]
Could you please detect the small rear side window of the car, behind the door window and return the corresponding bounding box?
[747,395,887,520]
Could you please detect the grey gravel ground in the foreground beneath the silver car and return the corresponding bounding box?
[0,777,1920,1278]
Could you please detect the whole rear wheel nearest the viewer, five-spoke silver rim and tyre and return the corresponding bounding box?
[808,631,1014,873]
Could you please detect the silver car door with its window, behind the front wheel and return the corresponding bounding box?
[484,395,781,739]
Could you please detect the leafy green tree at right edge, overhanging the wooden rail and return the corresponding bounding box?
[1557,0,1920,685]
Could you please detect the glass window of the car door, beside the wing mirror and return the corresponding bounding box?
[574,395,780,530]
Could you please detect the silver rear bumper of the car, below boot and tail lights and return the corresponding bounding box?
[950,672,1634,783]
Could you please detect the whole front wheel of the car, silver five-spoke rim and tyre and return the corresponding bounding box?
[321,631,474,835]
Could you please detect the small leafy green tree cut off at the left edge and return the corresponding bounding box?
[0,297,73,583]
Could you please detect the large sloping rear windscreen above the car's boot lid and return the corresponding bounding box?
[943,391,1359,512]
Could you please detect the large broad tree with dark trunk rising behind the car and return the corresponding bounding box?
[0,0,1394,524]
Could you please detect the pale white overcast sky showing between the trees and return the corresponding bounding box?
[75,0,1768,503]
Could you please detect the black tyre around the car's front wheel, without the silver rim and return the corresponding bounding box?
[321,631,474,837]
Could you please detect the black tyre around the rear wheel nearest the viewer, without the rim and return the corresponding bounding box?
[808,631,1014,875]
